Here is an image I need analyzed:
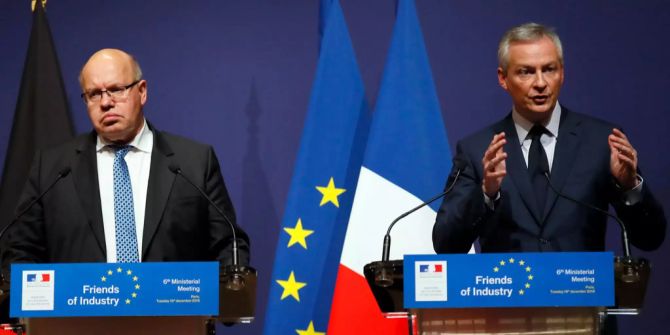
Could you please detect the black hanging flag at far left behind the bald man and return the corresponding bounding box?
[0,0,74,234]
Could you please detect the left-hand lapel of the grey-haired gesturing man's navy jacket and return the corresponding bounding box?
[502,114,542,225]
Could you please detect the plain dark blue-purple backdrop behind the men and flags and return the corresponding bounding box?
[0,0,670,334]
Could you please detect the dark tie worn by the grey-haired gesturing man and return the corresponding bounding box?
[528,125,549,215]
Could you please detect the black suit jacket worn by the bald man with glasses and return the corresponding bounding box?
[3,126,249,264]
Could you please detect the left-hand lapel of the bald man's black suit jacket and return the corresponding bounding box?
[72,132,107,257]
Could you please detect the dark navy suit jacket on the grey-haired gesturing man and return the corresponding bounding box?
[433,108,666,253]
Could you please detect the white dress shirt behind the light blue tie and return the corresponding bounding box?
[96,120,154,263]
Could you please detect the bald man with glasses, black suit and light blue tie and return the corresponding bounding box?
[3,49,249,267]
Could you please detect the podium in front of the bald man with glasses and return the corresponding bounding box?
[2,262,257,335]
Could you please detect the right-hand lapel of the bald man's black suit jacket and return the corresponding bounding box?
[142,124,176,259]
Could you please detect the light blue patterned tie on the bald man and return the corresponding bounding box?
[113,145,139,263]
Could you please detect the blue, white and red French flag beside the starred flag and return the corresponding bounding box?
[327,0,452,335]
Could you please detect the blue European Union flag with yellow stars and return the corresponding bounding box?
[264,1,369,335]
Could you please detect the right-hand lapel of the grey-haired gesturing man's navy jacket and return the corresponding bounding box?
[543,108,580,220]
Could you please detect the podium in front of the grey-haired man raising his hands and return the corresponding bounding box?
[364,253,650,335]
